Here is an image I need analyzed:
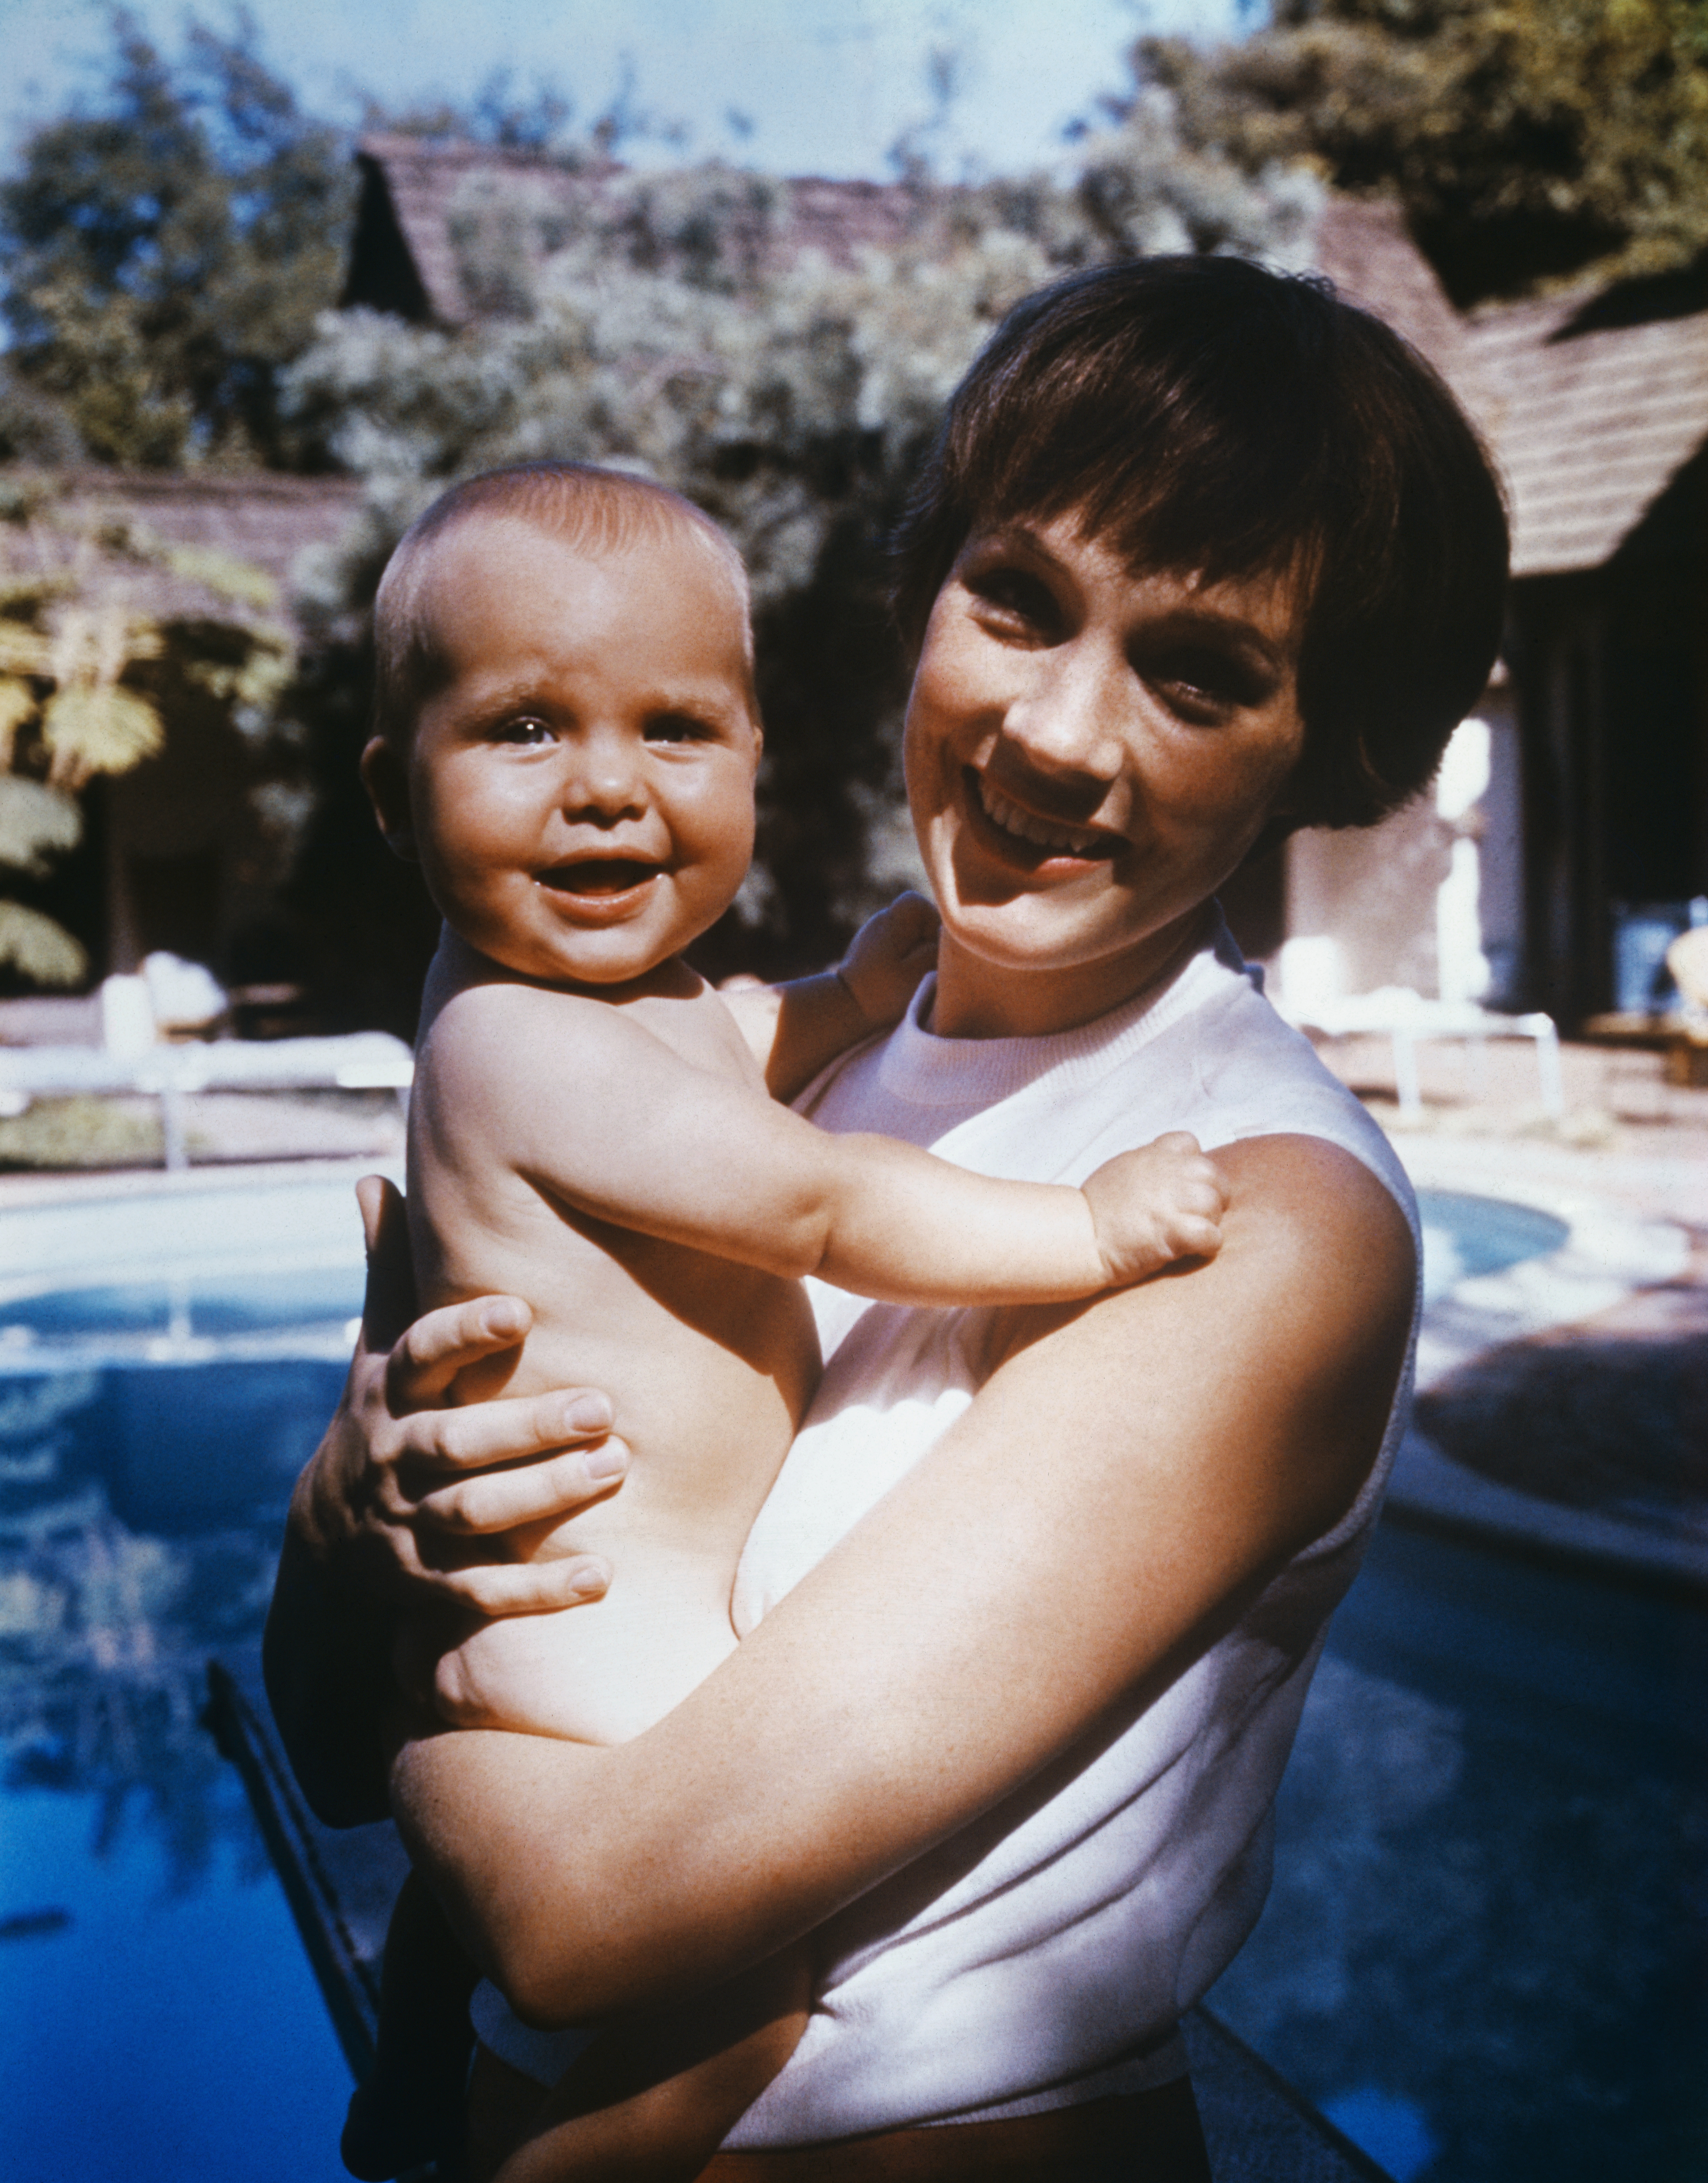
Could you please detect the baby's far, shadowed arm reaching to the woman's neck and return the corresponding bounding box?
[723,893,939,1100]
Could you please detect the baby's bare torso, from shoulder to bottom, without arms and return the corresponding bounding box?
[408,954,819,1742]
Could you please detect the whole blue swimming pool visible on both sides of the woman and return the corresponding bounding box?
[0,1174,1708,2183]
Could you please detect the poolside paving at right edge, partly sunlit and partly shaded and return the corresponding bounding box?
[1324,1039,1708,1596]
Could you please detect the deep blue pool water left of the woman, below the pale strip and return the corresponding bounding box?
[0,1344,350,2183]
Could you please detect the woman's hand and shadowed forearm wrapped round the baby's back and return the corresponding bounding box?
[262,1174,629,1827]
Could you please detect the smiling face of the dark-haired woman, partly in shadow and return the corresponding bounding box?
[906,515,1304,1037]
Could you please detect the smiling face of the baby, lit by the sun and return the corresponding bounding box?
[393,520,760,989]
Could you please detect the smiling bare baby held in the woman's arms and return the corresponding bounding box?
[345,463,1225,2183]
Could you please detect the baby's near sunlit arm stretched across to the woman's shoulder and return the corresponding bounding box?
[461,989,1225,1305]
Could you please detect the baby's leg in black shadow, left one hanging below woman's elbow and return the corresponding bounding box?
[338,1873,480,2183]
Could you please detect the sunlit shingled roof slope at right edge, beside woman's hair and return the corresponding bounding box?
[1467,290,1708,576]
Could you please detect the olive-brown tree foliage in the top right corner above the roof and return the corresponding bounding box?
[1134,0,1708,304]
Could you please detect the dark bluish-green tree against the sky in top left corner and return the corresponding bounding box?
[0,9,351,467]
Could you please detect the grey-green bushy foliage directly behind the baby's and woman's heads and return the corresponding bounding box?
[286,140,1319,993]
